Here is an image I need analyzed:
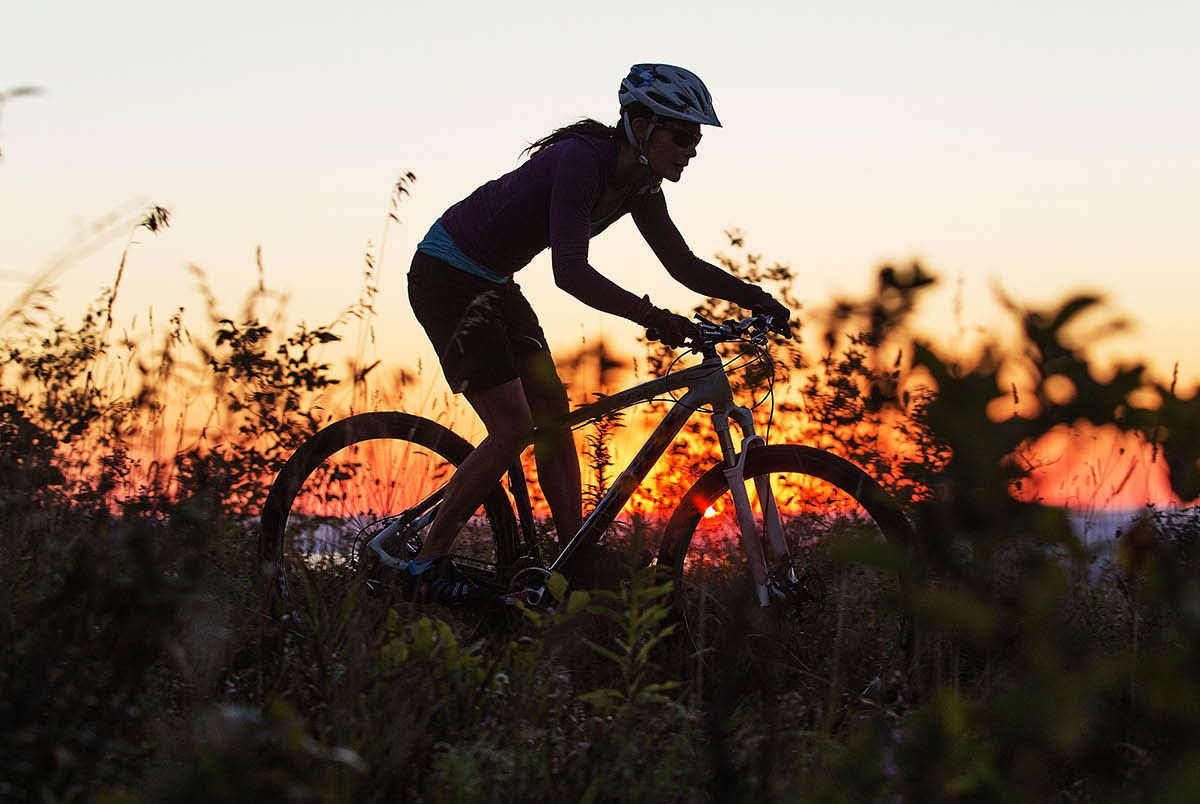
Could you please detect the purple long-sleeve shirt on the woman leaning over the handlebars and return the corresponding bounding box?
[442,134,762,323]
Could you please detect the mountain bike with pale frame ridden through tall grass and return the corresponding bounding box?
[259,314,913,652]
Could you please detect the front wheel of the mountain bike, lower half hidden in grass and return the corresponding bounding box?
[658,444,914,695]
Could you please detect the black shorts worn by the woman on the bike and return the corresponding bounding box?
[408,251,546,394]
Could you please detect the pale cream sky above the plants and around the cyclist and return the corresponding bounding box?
[0,0,1200,379]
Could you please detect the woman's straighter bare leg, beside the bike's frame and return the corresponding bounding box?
[518,349,583,546]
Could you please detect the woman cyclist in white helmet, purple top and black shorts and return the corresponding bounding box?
[406,64,790,602]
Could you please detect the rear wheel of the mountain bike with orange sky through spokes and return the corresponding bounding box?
[258,412,517,624]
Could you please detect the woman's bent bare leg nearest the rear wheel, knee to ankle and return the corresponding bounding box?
[416,379,532,560]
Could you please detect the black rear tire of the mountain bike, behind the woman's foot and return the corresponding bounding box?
[258,412,517,620]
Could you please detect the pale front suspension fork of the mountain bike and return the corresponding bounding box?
[713,407,797,606]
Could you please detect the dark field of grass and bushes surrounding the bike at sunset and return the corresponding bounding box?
[0,210,1200,802]
